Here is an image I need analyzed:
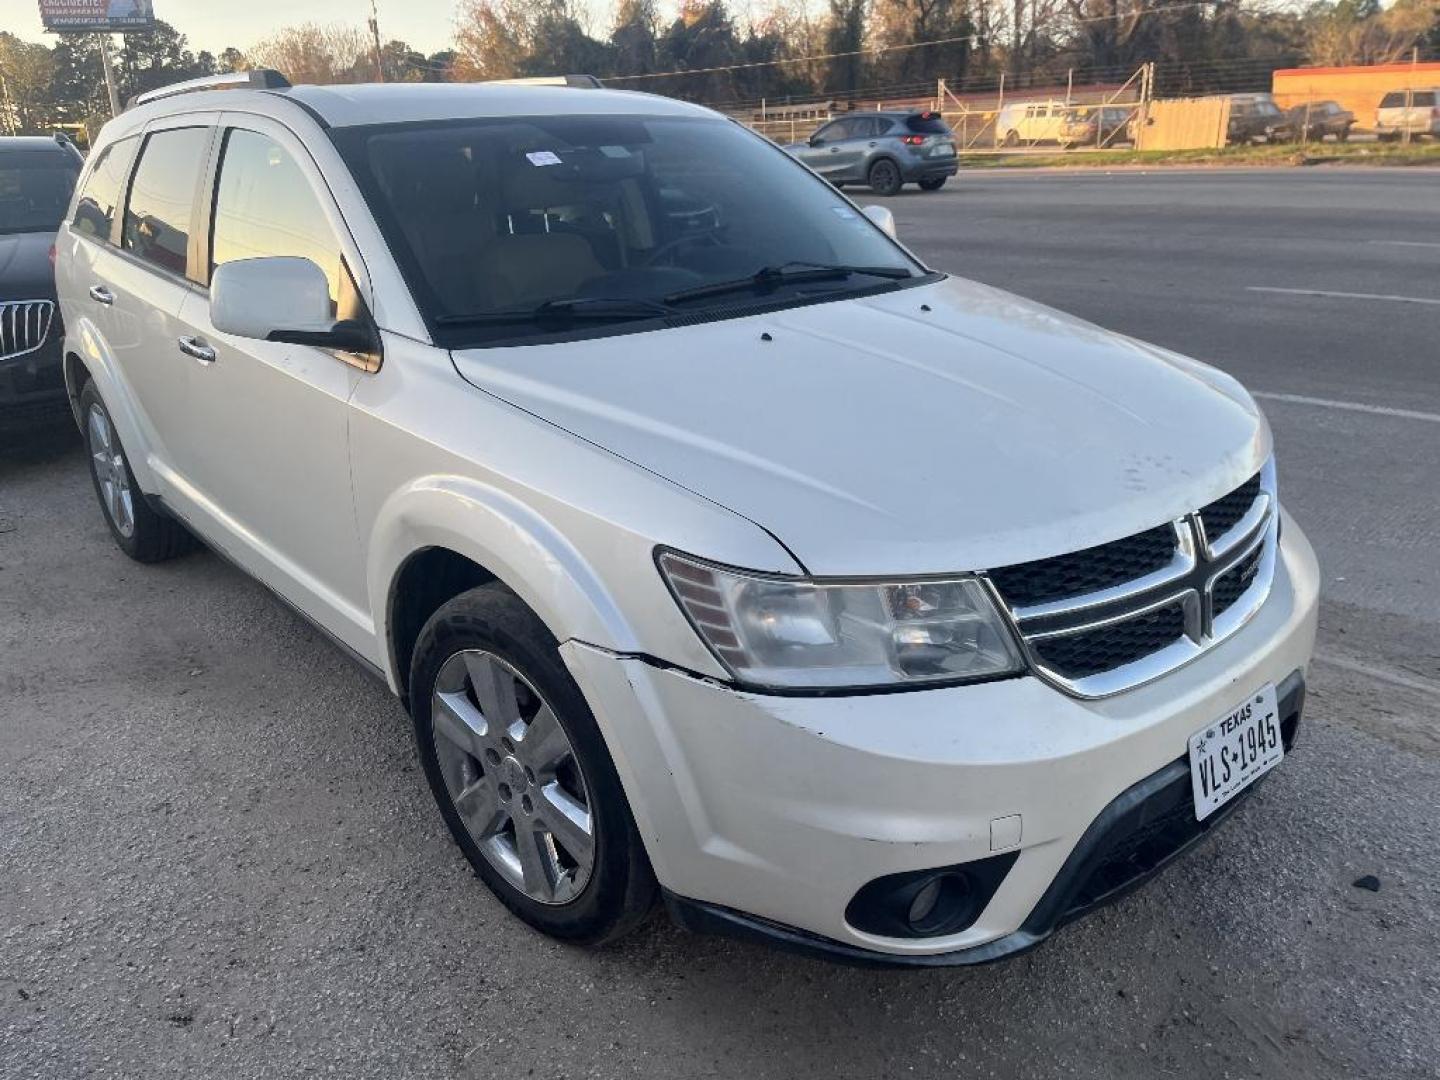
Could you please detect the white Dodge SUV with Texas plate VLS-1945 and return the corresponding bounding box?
[56,73,1316,965]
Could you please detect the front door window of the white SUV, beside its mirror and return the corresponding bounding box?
[210,128,341,302]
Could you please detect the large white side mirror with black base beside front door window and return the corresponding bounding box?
[210,255,374,353]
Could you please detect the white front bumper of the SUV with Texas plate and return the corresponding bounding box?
[562,518,1318,963]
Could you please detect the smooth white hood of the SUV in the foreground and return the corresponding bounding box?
[454,278,1270,575]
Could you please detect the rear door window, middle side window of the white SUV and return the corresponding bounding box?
[121,128,210,275]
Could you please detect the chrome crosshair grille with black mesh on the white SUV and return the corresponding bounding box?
[989,462,1279,697]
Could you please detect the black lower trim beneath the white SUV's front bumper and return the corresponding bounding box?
[662,671,1305,968]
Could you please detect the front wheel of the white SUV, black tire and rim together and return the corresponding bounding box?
[410,585,657,945]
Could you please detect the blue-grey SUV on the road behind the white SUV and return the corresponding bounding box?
[785,111,960,194]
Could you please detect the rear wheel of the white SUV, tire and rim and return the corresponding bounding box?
[81,379,196,563]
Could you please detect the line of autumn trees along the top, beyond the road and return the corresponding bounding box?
[0,0,1440,139]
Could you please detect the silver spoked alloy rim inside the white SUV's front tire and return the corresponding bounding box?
[431,649,595,904]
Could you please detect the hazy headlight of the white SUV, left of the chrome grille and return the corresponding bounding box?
[658,552,1024,690]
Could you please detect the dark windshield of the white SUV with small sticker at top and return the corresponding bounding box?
[331,115,923,346]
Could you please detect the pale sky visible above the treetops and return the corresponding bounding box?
[0,0,611,53]
